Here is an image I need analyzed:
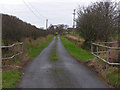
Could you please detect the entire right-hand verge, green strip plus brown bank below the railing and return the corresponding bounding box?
[61,36,120,88]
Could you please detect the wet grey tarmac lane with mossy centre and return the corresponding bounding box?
[18,37,107,88]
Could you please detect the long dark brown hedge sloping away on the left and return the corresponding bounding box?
[2,14,49,45]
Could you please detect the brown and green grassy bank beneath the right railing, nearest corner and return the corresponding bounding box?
[85,58,120,88]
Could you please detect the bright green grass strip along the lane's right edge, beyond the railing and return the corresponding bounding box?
[60,36,93,61]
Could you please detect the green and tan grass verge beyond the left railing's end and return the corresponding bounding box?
[26,36,53,58]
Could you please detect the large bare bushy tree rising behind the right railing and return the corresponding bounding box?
[77,2,117,44]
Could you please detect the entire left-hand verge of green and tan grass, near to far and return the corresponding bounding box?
[2,35,53,88]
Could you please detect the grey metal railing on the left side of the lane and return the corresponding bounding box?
[0,42,23,61]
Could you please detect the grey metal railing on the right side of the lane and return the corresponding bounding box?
[91,42,120,70]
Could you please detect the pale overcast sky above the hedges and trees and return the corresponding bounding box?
[0,0,119,28]
